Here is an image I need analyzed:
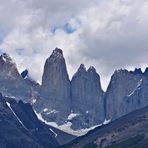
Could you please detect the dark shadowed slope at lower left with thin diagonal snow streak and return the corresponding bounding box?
[0,94,59,148]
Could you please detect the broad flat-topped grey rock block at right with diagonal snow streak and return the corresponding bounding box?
[105,69,148,120]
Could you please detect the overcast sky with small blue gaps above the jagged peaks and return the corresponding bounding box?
[0,0,148,89]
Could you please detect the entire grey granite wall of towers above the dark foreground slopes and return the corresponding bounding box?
[0,48,148,134]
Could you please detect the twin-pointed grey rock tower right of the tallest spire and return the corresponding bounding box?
[71,64,105,128]
